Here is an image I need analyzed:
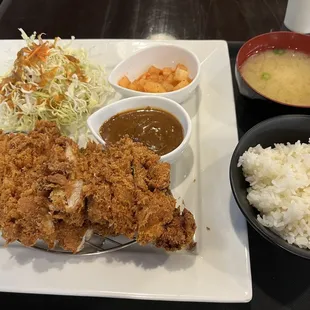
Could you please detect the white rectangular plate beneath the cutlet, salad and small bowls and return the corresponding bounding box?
[0,40,252,302]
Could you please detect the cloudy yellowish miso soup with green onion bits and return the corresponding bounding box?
[240,49,310,106]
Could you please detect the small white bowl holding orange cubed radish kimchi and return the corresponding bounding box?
[108,45,200,103]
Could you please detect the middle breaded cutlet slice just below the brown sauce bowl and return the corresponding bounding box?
[79,140,136,238]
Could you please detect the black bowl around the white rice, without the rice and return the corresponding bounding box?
[229,115,310,259]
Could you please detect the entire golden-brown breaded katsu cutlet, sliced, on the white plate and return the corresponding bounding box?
[0,121,196,253]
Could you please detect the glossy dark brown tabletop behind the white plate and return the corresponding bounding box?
[0,0,287,41]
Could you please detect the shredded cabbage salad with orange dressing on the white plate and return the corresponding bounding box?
[0,29,113,139]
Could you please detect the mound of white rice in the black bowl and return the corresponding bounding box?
[238,141,310,249]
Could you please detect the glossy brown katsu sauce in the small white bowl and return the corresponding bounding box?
[99,107,184,156]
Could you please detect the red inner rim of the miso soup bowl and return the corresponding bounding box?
[236,31,310,109]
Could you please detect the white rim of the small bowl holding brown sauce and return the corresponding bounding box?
[87,96,192,164]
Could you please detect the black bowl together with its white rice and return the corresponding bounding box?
[230,115,310,259]
